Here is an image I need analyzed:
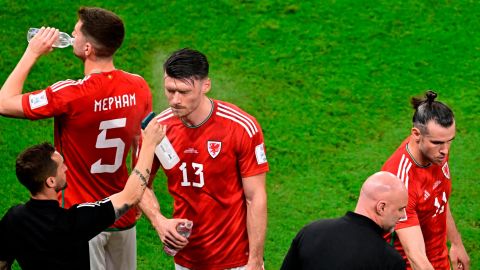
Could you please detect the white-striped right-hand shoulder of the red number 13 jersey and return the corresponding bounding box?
[214,100,261,137]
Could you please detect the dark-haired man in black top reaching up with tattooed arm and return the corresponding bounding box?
[0,121,165,270]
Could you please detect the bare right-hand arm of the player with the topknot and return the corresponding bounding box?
[447,203,470,270]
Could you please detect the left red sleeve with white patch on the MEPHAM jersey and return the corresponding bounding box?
[22,80,82,120]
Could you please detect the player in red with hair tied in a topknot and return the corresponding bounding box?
[382,91,470,270]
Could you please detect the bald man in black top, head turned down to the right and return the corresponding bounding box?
[281,172,408,270]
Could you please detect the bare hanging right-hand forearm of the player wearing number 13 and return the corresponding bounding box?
[247,190,267,266]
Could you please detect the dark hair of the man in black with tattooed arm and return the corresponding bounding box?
[16,142,58,195]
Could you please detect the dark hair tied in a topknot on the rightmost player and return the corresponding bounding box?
[411,90,454,133]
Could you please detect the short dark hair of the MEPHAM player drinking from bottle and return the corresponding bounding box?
[78,7,125,58]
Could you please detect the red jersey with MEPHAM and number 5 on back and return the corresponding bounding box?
[22,70,152,229]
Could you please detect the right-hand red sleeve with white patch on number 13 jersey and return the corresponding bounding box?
[238,118,269,178]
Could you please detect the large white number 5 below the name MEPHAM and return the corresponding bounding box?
[90,118,127,173]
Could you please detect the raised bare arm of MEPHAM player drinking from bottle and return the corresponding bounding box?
[0,27,59,118]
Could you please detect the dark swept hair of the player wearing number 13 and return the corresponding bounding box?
[163,48,209,81]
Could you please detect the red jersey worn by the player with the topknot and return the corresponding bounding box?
[382,138,452,269]
